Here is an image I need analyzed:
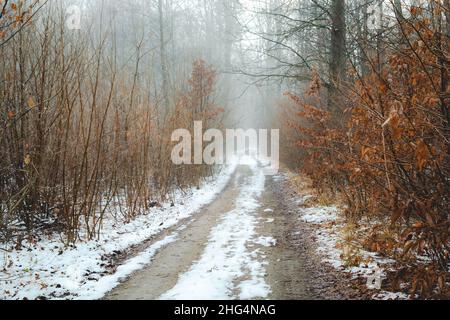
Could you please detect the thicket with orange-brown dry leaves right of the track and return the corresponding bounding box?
[272,0,450,297]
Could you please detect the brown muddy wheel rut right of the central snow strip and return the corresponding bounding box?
[259,173,367,300]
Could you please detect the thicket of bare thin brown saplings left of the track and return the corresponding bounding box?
[0,0,228,243]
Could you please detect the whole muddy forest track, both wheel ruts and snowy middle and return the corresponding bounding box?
[105,166,358,300]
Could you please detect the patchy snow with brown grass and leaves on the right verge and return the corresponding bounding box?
[297,182,408,300]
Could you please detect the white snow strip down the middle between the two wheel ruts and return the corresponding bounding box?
[160,161,273,300]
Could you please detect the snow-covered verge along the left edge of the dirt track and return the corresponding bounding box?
[0,165,236,299]
